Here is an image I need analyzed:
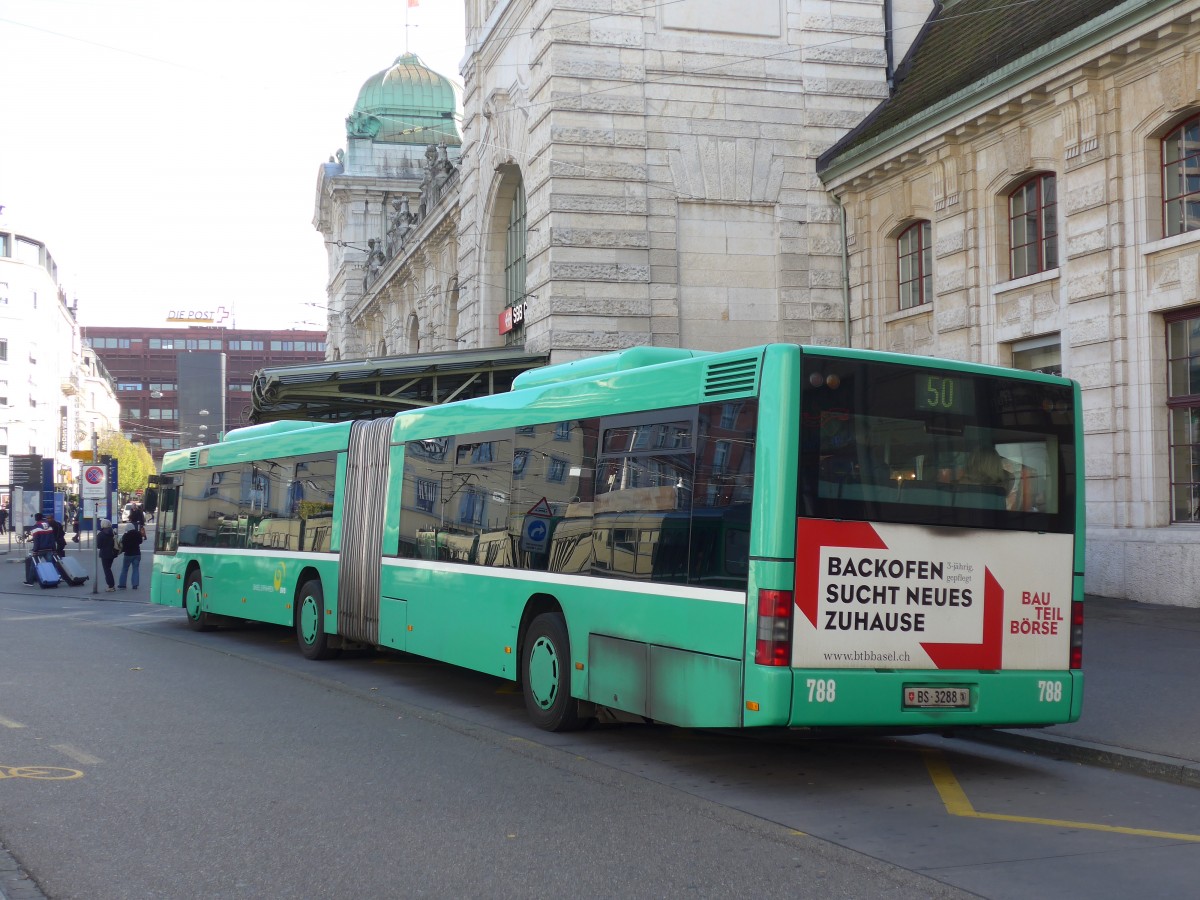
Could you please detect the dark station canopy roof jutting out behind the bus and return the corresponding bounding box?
[250,347,550,424]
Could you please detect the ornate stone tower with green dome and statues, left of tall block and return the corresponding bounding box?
[313,53,461,360]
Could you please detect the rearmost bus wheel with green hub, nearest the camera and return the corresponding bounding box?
[521,612,587,731]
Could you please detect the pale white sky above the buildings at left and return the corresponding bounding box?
[0,0,464,330]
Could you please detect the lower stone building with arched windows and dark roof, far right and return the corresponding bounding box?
[821,0,1200,606]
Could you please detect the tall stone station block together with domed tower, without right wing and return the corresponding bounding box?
[314,0,930,362]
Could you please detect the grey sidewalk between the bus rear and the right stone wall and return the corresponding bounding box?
[960,596,1200,787]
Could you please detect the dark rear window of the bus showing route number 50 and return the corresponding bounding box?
[799,356,1075,532]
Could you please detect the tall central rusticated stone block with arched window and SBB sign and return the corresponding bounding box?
[458,0,929,362]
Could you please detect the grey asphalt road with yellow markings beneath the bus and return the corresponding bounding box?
[0,559,1200,900]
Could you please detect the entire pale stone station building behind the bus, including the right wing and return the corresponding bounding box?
[317,0,1200,605]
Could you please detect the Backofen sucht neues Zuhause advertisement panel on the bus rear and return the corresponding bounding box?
[792,520,1073,670]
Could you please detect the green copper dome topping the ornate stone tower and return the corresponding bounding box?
[346,53,462,146]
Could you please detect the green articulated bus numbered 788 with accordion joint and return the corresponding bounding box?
[145,344,1084,731]
